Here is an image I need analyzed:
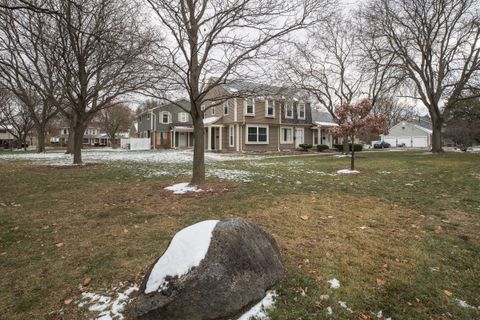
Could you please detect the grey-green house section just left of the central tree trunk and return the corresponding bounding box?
[136,99,193,149]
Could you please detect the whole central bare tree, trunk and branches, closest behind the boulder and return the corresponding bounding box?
[147,0,330,185]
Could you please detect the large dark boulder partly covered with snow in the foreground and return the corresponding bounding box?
[131,219,283,320]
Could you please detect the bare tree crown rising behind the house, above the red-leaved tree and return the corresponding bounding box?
[282,12,398,120]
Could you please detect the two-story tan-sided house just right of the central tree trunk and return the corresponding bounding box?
[202,80,318,151]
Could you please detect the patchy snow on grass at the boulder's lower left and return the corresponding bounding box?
[78,284,138,320]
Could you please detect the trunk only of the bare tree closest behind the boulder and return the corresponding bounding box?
[190,114,205,186]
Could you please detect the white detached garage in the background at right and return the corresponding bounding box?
[382,121,432,148]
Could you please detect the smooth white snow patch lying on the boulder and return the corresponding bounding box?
[145,220,218,293]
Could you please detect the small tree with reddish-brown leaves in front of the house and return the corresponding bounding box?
[330,99,388,170]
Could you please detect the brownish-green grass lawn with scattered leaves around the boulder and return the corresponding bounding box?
[0,151,480,320]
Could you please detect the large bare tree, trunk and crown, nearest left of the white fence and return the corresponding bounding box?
[47,0,156,163]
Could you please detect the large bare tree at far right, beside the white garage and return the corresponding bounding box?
[364,0,480,152]
